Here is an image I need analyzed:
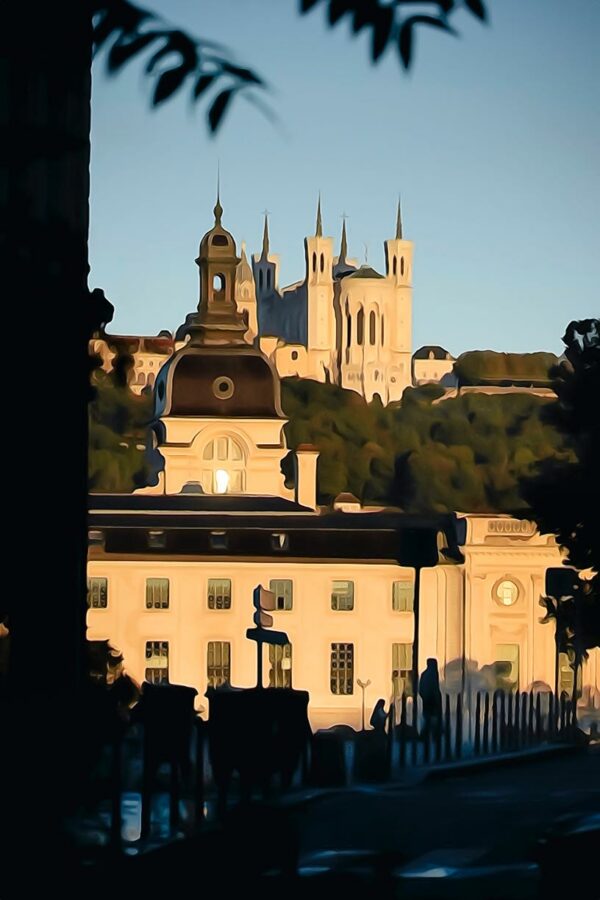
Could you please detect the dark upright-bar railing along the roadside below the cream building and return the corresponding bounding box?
[81,691,574,848]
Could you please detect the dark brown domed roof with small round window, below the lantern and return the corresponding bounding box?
[155,343,284,419]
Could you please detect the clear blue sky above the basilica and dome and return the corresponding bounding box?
[90,0,600,354]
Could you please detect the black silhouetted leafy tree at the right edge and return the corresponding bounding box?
[520,319,600,658]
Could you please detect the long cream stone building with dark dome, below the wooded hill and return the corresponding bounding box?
[88,201,600,728]
